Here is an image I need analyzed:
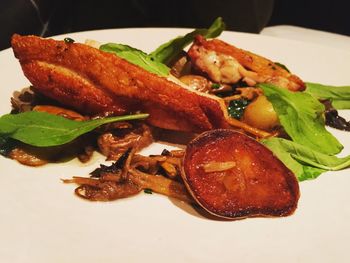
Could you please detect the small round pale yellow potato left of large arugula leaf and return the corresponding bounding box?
[242,95,279,131]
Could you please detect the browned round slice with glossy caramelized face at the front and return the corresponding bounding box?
[182,129,299,219]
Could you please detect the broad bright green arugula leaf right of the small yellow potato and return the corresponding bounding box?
[259,84,343,155]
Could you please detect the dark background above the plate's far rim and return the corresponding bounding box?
[0,0,350,49]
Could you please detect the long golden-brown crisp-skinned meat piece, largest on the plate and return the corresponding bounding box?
[12,35,229,132]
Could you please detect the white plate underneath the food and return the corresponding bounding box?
[0,28,350,263]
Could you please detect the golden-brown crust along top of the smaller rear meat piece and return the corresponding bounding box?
[188,36,305,91]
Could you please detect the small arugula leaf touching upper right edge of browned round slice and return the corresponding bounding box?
[261,138,326,181]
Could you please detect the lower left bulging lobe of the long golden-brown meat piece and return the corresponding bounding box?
[22,61,133,115]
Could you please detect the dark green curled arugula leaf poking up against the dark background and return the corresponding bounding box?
[150,17,225,64]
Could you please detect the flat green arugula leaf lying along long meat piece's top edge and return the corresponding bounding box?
[100,43,170,77]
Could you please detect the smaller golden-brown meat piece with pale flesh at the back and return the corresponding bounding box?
[188,36,305,91]
